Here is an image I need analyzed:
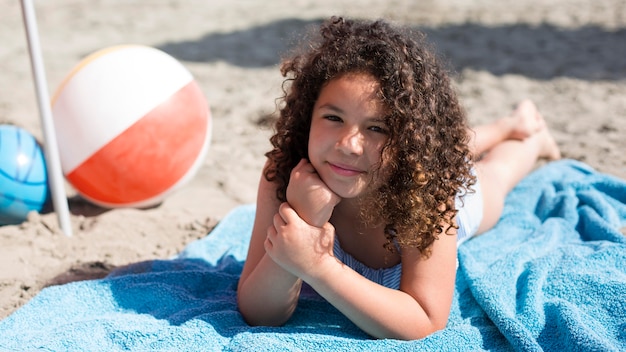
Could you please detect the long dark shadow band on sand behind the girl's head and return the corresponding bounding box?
[158,19,626,81]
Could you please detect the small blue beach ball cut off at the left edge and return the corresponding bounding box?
[0,125,50,225]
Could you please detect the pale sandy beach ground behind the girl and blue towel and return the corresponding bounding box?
[0,0,626,318]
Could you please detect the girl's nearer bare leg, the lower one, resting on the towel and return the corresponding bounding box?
[476,103,561,233]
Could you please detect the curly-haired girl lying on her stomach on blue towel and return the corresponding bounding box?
[237,17,560,339]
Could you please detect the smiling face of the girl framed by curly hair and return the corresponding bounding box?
[308,73,388,198]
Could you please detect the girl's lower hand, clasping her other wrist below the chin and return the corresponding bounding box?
[264,203,335,279]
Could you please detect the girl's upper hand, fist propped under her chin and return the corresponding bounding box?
[287,159,341,227]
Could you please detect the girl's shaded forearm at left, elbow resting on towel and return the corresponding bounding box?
[237,255,302,326]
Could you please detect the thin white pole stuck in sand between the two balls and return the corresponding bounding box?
[21,0,72,237]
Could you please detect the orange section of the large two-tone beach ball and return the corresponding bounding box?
[67,81,210,205]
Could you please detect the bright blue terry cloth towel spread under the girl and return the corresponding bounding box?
[0,160,626,351]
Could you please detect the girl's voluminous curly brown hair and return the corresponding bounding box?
[264,17,475,256]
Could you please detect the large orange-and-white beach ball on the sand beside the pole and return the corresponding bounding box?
[52,45,211,208]
